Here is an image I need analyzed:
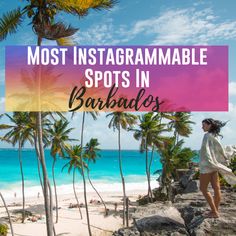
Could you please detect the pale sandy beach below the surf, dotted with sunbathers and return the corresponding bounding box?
[0,190,146,236]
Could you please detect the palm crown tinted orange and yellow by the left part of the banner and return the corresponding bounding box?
[9,66,71,111]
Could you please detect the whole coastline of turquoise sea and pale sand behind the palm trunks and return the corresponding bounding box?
[0,149,160,236]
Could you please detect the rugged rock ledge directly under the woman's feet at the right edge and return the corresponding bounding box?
[173,189,236,236]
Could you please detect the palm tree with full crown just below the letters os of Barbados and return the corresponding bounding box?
[132,112,164,201]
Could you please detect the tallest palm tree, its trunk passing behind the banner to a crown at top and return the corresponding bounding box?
[0,0,116,236]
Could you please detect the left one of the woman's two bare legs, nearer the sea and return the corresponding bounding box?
[200,173,218,217]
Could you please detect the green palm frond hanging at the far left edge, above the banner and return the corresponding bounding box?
[0,8,23,41]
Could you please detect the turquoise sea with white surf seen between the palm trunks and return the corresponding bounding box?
[0,149,161,197]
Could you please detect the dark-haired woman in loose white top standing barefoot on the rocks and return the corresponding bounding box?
[199,118,236,218]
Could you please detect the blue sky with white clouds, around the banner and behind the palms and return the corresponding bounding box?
[0,0,236,149]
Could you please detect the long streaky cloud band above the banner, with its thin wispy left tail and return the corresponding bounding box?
[76,8,236,45]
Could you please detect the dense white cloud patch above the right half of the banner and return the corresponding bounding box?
[134,8,236,45]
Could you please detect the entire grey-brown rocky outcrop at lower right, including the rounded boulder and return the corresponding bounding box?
[113,179,236,236]
